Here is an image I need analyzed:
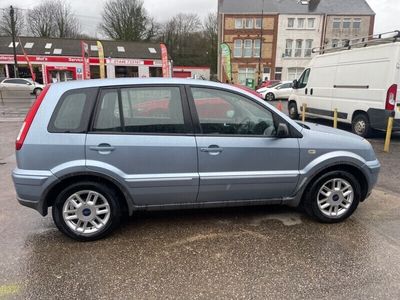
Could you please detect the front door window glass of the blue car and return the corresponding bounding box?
[191,88,276,137]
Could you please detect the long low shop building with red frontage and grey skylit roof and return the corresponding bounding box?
[0,37,172,84]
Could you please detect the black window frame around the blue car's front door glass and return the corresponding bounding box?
[186,85,303,139]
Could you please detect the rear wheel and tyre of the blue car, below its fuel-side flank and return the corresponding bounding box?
[52,181,121,242]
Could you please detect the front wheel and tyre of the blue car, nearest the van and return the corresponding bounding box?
[302,171,361,223]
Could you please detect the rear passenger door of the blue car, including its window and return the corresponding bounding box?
[86,86,199,206]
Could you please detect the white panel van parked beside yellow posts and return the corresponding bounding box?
[288,32,400,137]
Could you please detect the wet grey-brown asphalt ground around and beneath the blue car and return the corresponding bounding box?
[0,102,400,299]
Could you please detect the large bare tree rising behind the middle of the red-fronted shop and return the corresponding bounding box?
[100,0,156,41]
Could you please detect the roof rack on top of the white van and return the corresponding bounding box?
[312,30,400,54]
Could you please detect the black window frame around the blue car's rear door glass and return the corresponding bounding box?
[87,83,194,136]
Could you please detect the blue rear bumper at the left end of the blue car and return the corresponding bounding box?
[12,168,58,216]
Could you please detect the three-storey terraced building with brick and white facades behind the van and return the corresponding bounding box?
[218,0,375,84]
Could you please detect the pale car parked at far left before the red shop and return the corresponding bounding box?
[0,78,44,98]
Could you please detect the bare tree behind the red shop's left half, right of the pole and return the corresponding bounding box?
[27,0,80,38]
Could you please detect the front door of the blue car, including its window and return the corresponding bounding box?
[190,87,299,202]
